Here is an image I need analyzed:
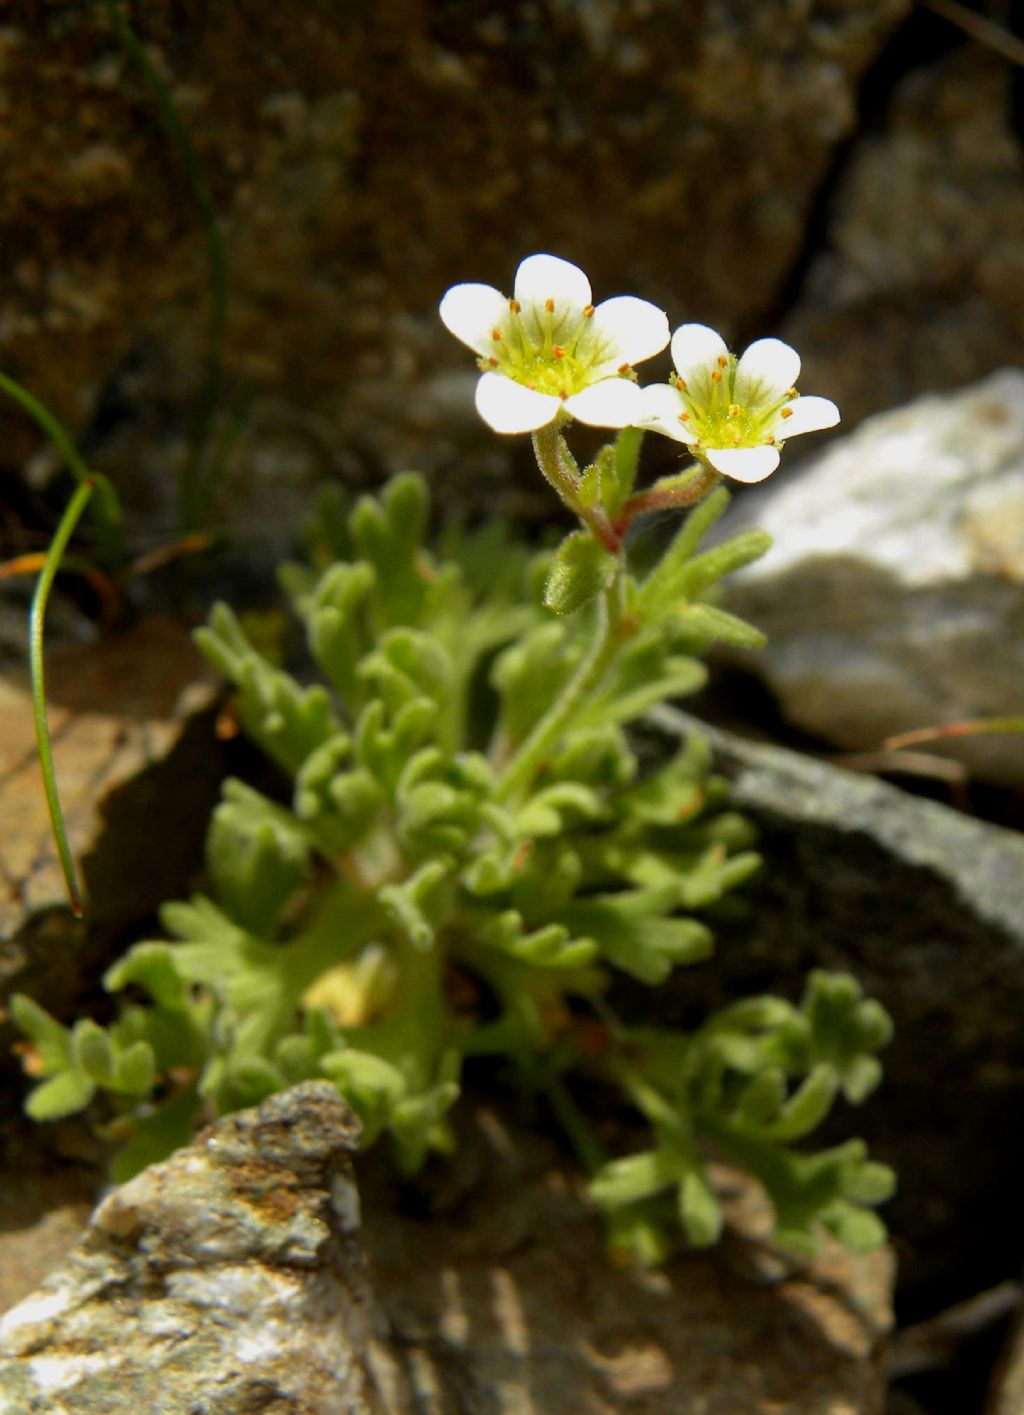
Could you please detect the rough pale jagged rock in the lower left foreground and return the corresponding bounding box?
[0,1082,379,1415]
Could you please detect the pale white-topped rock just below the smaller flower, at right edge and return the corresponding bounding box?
[724,369,1024,787]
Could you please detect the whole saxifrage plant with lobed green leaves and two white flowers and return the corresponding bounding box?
[11,256,892,1261]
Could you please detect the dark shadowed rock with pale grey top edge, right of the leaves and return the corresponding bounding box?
[644,710,1024,1310]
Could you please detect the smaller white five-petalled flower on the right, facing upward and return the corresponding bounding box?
[639,324,839,481]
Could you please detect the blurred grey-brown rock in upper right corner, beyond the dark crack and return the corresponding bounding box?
[784,49,1024,419]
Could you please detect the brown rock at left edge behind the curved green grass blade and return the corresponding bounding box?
[0,620,222,1081]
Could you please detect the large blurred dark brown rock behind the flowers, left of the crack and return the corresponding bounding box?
[0,0,909,539]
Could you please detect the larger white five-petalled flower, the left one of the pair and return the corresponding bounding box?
[440,255,669,433]
